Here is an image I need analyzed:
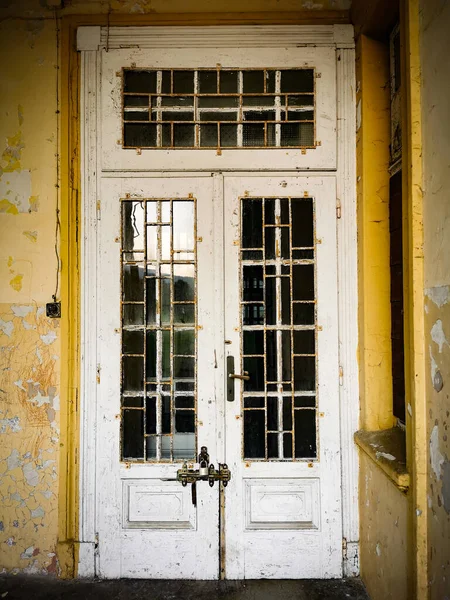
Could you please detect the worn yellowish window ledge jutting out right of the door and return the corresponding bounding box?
[355,427,410,492]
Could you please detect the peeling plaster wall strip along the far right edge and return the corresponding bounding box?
[421,0,450,600]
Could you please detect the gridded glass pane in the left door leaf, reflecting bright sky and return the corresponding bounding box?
[121,198,197,462]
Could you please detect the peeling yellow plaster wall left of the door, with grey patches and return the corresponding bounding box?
[0,16,60,574]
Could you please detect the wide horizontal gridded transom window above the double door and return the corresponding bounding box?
[123,68,316,149]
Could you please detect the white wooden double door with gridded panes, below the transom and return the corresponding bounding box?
[96,174,342,579]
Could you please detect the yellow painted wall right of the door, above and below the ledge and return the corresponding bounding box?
[356,35,412,600]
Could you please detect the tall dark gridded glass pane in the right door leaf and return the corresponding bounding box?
[240,197,317,460]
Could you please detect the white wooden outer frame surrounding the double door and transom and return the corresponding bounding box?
[77,25,359,577]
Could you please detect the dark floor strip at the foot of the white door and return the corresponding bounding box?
[0,575,369,600]
